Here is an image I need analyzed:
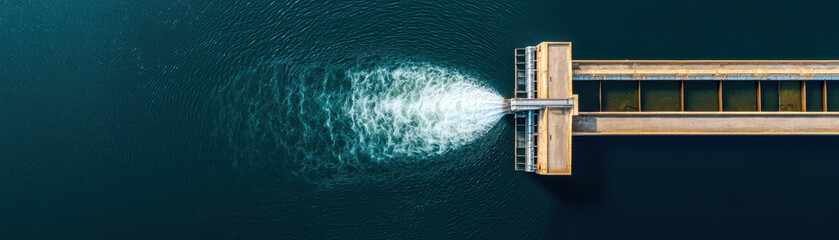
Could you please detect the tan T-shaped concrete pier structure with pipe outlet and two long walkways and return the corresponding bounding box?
[504,42,839,175]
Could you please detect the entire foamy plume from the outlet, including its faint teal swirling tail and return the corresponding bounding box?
[218,62,504,182]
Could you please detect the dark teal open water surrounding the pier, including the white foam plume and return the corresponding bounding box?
[0,0,839,239]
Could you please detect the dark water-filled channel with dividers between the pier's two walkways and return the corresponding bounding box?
[575,80,839,112]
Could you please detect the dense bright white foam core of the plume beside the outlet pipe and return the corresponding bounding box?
[343,64,504,160]
